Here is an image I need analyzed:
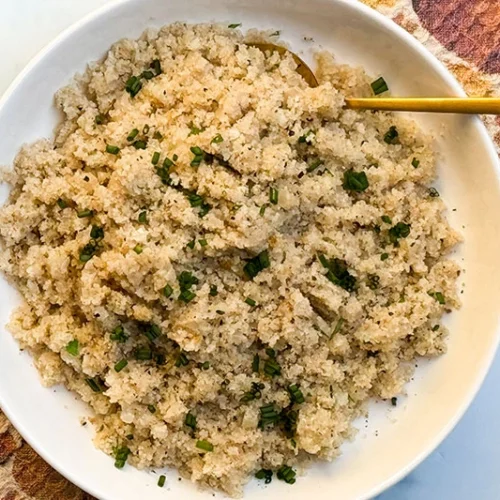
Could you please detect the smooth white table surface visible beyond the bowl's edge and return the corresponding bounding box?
[0,0,500,500]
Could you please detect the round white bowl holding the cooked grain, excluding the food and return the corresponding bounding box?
[0,0,500,500]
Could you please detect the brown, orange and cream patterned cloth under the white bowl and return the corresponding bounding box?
[0,0,500,500]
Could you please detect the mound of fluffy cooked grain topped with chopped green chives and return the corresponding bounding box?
[0,24,459,496]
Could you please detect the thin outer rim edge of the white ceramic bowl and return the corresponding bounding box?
[0,0,500,497]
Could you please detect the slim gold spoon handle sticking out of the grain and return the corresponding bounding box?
[346,97,500,115]
